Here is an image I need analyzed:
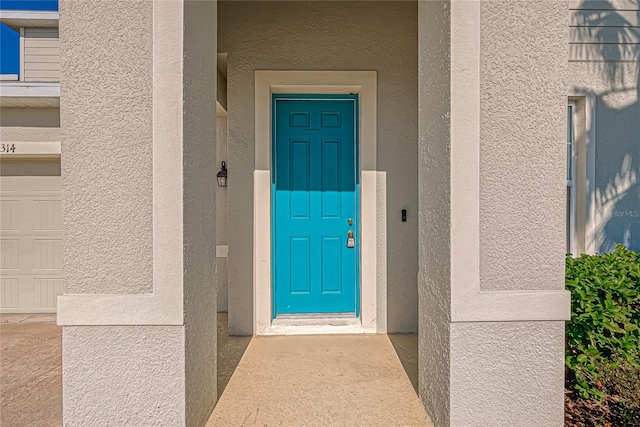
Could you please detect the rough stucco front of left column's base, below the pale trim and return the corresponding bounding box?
[62,326,185,427]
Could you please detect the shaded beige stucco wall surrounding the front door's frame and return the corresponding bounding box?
[218,1,418,334]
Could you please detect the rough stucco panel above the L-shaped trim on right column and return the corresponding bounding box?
[479,0,569,290]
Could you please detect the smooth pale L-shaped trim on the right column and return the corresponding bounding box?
[450,1,570,322]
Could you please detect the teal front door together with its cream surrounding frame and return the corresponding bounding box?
[253,71,386,335]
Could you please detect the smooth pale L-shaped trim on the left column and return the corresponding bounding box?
[58,0,186,326]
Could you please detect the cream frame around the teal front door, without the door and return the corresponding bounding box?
[253,70,387,335]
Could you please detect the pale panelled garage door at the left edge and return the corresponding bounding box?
[0,160,62,313]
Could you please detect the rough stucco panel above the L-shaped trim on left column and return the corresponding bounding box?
[60,0,153,294]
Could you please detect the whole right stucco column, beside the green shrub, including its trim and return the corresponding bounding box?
[418,0,569,427]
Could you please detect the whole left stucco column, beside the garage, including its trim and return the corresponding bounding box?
[58,0,217,426]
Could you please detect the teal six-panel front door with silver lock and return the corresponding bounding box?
[272,95,360,318]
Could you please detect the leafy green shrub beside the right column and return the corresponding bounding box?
[565,245,640,406]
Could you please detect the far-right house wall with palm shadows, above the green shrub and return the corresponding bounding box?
[570,0,640,253]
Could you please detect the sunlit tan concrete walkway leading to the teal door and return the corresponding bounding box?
[207,335,433,427]
